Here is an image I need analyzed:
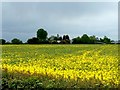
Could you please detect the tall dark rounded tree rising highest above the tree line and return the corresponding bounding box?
[37,28,48,41]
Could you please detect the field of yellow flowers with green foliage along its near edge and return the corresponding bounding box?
[0,45,120,90]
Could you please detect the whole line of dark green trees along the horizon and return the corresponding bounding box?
[0,28,118,44]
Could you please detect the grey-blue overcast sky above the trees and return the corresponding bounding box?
[2,2,118,42]
